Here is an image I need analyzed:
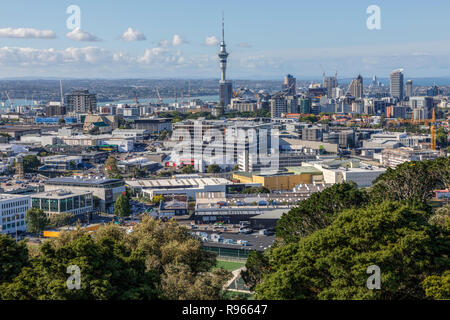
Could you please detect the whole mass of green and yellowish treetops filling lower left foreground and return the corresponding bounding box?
[0,217,230,300]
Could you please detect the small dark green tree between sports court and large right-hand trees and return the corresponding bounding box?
[241,250,269,291]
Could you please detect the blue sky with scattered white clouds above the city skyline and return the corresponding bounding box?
[0,0,450,79]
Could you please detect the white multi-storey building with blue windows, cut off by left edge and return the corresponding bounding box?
[0,194,30,234]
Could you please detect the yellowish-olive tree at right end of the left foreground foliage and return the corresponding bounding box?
[126,217,231,300]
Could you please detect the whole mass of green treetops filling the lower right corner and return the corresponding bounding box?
[243,158,450,299]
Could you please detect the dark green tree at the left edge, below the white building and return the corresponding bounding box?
[0,234,28,285]
